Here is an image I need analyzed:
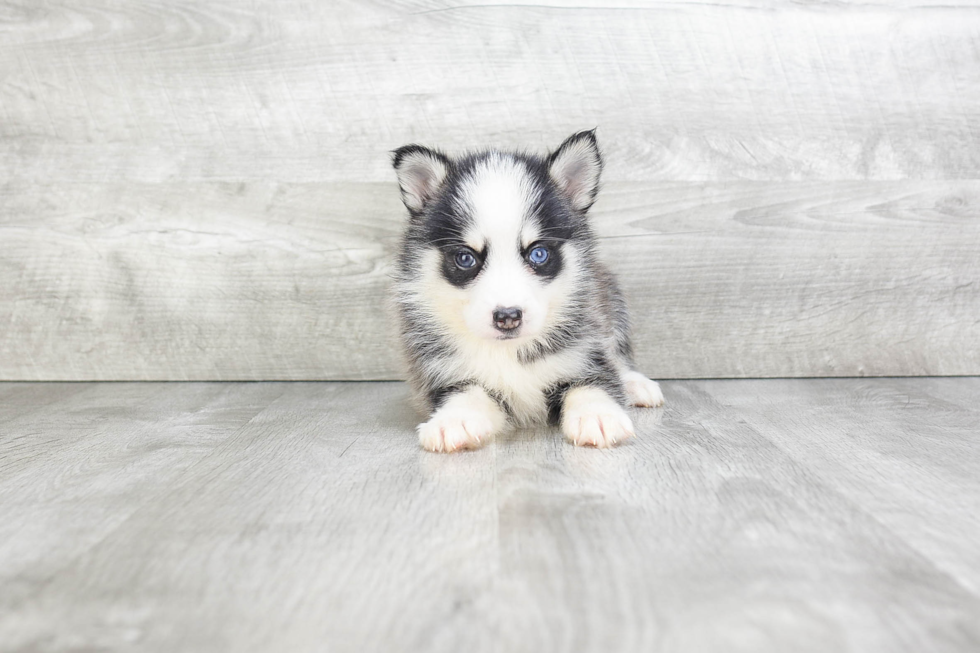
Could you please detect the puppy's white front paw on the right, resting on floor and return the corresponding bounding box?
[561,386,636,448]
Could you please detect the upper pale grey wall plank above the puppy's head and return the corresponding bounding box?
[0,0,980,182]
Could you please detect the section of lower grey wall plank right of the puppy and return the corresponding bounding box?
[597,182,980,378]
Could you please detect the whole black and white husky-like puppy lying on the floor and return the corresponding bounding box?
[394,131,663,451]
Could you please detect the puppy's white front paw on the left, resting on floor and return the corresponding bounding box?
[418,385,507,453]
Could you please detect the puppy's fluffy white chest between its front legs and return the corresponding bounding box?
[463,350,580,423]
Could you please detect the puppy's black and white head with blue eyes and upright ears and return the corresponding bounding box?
[394,131,602,342]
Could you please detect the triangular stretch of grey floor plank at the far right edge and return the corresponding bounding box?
[706,379,980,594]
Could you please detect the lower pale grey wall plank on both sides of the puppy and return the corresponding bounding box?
[0,182,980,380]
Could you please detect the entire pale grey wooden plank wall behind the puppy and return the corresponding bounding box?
[0,0,980,380]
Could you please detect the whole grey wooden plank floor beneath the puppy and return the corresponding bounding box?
[0,378,980,653]
